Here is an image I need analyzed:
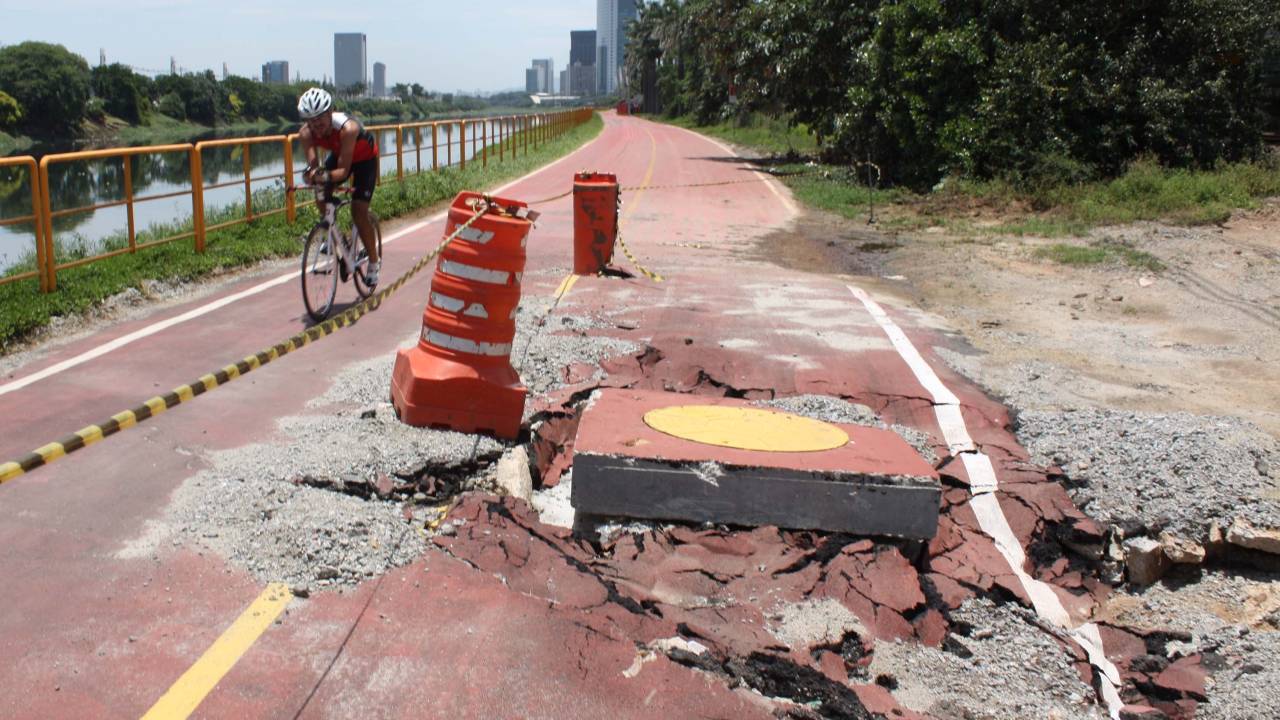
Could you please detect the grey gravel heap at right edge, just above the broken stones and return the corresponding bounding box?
[1018,409,1280,542]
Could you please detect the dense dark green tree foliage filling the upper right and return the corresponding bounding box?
[627,0,1280,187]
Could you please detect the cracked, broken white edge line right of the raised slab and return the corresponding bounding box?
[846,286,1124,720]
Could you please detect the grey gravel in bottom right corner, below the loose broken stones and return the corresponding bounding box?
[1107,570,1280,720]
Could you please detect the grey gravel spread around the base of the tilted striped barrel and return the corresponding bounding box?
[120,281,636,593]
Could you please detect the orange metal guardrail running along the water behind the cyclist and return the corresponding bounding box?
[0,108,593,292]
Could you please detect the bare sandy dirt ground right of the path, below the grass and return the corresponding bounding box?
[762,199,1280,438]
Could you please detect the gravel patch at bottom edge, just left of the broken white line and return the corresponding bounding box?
[869,598,1106,720]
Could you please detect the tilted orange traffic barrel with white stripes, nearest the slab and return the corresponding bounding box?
[392,192,532,438]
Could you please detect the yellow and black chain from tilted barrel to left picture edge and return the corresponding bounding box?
[0,204,492,483]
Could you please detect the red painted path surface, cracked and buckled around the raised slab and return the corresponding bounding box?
[0,114,1199,719]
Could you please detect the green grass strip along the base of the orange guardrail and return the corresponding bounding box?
[0,109,604,354]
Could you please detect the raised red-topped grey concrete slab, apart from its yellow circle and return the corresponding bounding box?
[572,389,941,539]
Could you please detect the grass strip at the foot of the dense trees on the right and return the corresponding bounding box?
[664,112,1280,238]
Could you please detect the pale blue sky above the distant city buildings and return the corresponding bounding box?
[0,0,595,92]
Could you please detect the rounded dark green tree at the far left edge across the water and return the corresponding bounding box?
[0,41,90,135]
